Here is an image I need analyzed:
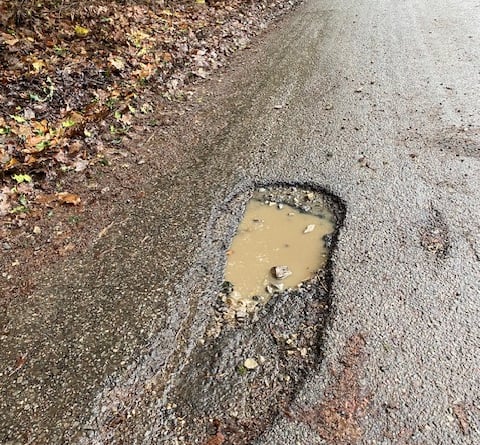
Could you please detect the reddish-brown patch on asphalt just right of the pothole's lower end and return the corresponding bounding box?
[289,334,369,445]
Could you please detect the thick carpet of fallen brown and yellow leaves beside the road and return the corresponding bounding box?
[0,0,293,225]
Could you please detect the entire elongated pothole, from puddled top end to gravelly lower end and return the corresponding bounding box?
[157,185,344,445]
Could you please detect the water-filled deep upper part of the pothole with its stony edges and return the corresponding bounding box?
[224,187,335,320]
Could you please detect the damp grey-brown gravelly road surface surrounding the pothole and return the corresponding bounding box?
[0,0,480,445]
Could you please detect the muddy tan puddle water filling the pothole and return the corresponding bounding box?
[225,199,335,309]
